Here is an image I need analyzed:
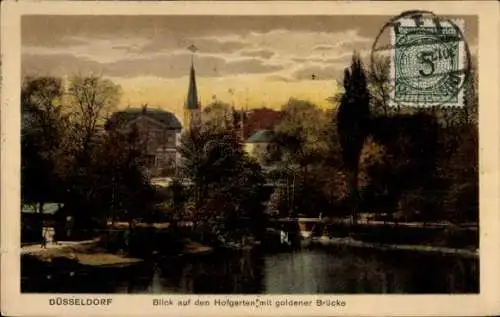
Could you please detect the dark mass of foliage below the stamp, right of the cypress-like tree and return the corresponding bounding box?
[352,110,479,222]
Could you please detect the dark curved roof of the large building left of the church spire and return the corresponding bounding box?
[105,108,182,130]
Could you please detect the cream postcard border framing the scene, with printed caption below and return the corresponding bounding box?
[1,1,500,316]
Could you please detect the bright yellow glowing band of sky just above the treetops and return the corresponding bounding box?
[112,75,338,120]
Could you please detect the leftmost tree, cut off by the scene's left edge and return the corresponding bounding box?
[21,77,67,212]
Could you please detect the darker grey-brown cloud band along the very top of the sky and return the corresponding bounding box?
[21,15,390,46]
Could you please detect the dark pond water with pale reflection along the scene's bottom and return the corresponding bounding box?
[22,249,479,294]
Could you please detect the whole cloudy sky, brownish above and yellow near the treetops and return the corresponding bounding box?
[21,15,477,119]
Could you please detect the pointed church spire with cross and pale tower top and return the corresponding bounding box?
[184,45,201,129]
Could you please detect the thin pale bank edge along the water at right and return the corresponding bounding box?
[311,237,479,259]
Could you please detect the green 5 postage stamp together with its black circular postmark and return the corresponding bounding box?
[371,11,471,107]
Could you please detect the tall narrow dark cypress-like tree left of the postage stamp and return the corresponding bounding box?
[337,53,370,223]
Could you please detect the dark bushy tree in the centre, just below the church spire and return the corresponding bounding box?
[179,127,264,238]
